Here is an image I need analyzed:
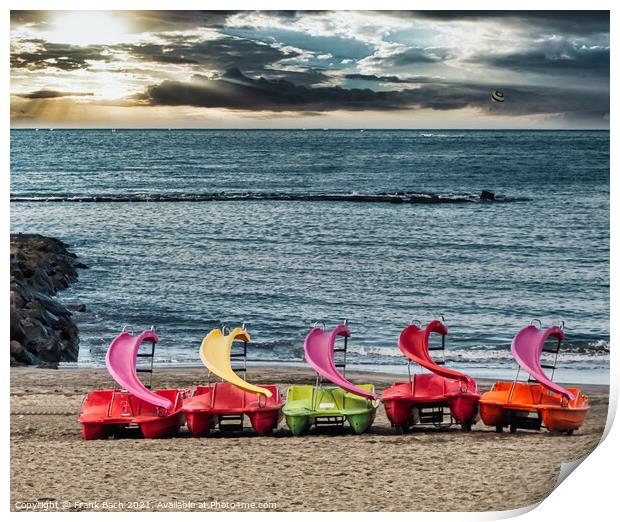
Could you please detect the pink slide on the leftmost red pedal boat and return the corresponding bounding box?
[105,330,172,410]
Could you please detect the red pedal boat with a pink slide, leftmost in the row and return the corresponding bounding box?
[79,329,186,440]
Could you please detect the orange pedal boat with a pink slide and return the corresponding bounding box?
[480,321,590,434]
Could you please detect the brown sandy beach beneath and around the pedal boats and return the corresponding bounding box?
[11,367,608,511]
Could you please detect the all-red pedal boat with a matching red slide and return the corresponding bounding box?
[381,320,480,433]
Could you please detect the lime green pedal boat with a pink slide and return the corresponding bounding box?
[282,323,379,435]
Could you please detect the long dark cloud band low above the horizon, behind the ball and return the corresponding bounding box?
[135,69,609,117]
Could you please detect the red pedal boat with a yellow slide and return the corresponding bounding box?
[183,327,283,437]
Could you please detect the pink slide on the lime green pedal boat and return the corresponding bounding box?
[304,324,377,400]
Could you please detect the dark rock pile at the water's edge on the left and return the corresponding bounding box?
[10,234,88,367]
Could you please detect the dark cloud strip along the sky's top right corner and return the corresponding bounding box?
[402,11,609,35]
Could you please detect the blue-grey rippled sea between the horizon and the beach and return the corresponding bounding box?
[11,129,609,382]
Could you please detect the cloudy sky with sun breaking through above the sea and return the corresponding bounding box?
[10,11,610,129]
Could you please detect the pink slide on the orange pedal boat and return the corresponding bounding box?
[511,324,575,401]
